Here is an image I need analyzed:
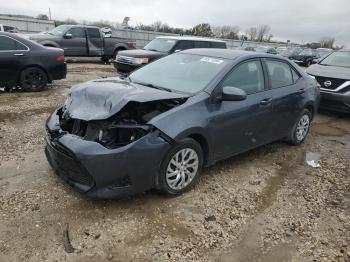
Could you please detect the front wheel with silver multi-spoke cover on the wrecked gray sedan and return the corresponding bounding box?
[158,138,203,196]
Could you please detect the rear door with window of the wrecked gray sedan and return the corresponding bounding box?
[264,58,305,139]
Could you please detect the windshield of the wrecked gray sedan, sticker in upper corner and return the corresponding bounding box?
[130,53,229,94]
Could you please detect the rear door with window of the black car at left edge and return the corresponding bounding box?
[0,36,29,86]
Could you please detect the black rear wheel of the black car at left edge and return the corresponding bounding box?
[20,67,48,92]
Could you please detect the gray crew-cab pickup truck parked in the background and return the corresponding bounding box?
[30,25,136,61]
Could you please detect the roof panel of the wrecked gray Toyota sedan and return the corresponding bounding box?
[181,48,285,60]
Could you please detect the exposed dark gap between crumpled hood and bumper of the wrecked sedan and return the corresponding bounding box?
[57,99,185,149]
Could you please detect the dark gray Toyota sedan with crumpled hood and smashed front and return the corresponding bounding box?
[45,49,319,198]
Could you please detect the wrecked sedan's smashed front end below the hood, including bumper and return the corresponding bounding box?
[46,90,187,198]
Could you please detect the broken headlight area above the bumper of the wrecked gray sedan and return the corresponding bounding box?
[98,124,153,149]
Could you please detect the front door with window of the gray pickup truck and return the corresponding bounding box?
[61,27,88,56]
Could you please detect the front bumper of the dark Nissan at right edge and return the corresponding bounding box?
[320,90,350,113]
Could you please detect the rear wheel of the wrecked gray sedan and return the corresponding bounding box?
[287,109,312,145]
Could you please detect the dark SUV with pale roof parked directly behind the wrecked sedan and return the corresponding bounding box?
[113,36,227,74]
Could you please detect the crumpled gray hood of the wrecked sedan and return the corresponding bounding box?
[64,77,188,121]
